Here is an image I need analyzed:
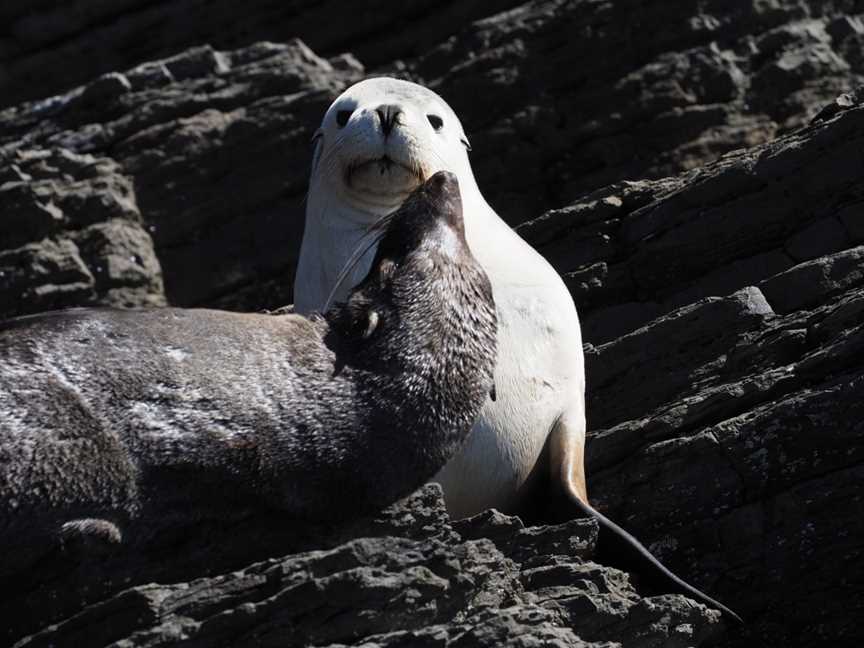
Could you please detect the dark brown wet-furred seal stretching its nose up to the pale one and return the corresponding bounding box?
[0,172,497,571]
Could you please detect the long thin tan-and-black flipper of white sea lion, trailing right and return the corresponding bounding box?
[549,417,744,624]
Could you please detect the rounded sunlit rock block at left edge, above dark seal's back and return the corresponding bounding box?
[0,148,165,315]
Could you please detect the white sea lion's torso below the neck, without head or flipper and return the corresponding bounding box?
[435,218,585,517]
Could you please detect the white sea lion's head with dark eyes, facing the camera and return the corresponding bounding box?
[312,77,473,216]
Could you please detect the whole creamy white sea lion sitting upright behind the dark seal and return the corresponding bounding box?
[294,78,737,619]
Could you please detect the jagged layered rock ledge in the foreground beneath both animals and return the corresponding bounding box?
[7,486,722,648]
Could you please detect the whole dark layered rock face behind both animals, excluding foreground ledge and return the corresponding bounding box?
[0,0,864,648]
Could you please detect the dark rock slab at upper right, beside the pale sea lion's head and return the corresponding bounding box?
[410,0,864,224]
